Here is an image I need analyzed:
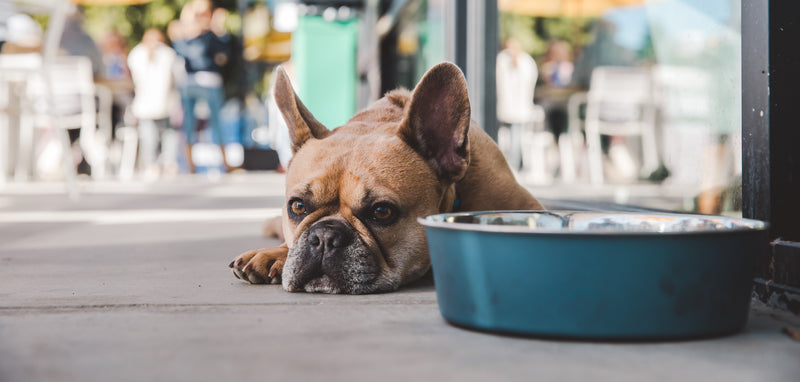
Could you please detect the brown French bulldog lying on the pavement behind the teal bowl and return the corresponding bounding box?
[230,63,543,294]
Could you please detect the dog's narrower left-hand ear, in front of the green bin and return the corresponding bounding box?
[275,67,331,153]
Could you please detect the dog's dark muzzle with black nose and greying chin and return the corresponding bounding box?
[282,220,381,294]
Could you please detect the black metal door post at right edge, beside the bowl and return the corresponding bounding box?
[742,0,800,313]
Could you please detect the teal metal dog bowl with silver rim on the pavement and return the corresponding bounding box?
[420,211,767,340]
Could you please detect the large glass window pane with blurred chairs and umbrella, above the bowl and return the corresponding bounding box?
[498,0,741,215]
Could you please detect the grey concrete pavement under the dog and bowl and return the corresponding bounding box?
[0,174,800,382]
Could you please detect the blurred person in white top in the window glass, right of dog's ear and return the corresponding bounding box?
[496,38,539,169]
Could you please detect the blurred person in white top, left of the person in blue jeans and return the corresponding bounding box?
[127,28,178,179]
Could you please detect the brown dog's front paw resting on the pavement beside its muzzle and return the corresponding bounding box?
[228,245,289,284]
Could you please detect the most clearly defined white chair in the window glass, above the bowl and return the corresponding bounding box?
[585,66,658,184]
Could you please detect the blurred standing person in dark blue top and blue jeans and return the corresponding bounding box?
[169,0,231,172]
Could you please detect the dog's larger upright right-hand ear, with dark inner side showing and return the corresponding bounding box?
[398,62,471,182]
